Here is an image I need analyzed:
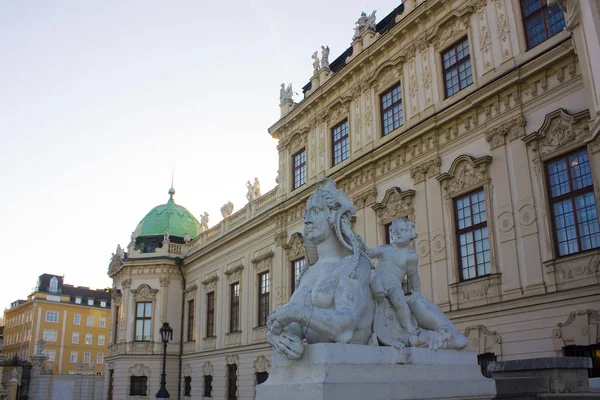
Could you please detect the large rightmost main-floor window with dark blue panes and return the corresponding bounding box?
[546,149,600,256]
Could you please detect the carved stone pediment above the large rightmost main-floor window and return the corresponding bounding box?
[523,108,590,158]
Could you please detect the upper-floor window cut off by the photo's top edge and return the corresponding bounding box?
[521,0,565,49]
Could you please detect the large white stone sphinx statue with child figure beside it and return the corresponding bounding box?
[267,179,467,359]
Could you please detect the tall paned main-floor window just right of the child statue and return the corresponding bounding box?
[455,189,491,280]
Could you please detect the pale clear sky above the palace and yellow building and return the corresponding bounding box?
[0,0,400,308]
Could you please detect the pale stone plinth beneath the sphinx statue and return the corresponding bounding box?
[256,343,496,400]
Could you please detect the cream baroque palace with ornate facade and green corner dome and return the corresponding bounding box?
[106,0,600,399]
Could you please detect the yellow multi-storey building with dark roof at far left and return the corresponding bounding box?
[1,274,110,374]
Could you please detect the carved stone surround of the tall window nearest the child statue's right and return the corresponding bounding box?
[436,154,501,308]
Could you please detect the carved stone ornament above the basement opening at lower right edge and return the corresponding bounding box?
[552,308,600,351]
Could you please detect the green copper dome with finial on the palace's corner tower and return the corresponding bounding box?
[135,188,200,240]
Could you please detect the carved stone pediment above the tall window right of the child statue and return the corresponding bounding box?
[437,155,492,196]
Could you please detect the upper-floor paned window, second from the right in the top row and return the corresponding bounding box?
[442,38,473,97]
